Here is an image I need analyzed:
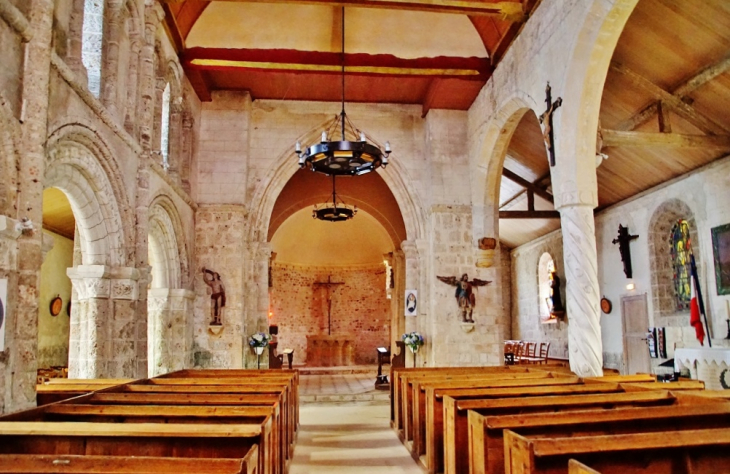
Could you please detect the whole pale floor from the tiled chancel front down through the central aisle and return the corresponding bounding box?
[289,367,423,474]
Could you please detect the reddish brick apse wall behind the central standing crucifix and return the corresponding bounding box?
[270,263,391,364]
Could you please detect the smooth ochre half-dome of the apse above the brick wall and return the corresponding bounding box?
[271,207,394,266]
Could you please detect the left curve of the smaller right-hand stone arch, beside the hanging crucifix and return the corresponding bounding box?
[472,92,536,240]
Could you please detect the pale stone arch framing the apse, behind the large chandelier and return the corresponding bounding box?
[248,120,426,242]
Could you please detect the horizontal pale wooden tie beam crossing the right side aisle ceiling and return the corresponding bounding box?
[601,129,730,149]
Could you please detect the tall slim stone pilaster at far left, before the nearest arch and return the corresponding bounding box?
[12,0,54,411]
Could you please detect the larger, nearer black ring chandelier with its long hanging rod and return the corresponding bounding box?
[295,7,391,176]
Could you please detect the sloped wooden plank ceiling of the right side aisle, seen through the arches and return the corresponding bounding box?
[500,0,730,247]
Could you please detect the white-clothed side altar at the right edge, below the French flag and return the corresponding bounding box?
[674,347,730,390]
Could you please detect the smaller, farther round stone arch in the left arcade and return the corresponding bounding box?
[148,194,190,289]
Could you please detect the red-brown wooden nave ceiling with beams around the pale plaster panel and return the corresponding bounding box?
[163,0,538,115]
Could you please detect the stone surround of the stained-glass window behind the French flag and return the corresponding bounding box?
[648,199,702,325]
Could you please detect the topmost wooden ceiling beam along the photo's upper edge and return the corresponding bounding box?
[161,0,525,22]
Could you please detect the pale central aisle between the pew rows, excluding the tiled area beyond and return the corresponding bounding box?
[289,402,423,474]
